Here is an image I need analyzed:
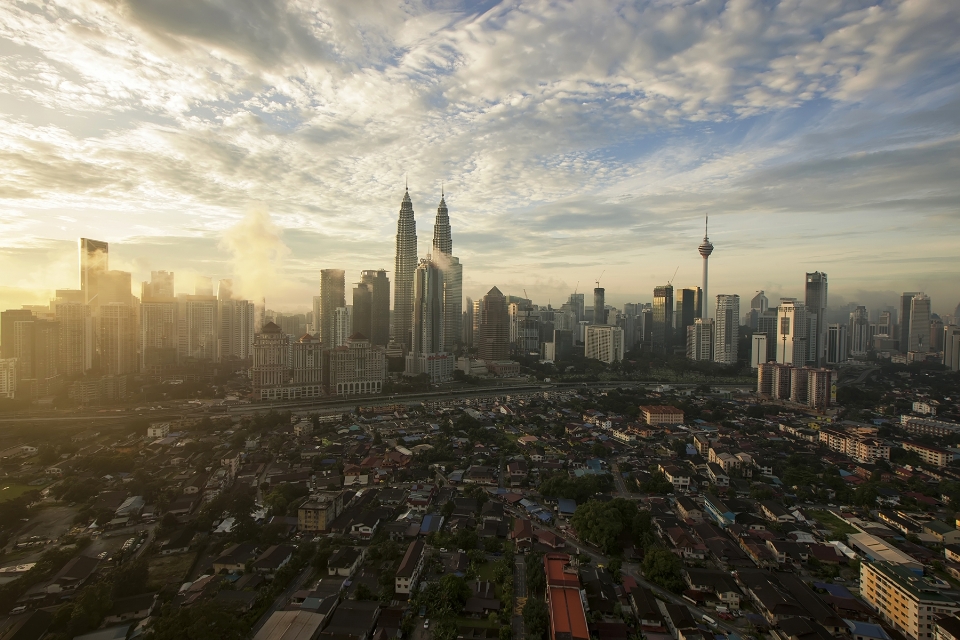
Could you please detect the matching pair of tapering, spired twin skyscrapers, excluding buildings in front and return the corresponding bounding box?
[393,189,453,345]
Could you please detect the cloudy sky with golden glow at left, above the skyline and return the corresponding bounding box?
[0,0,960,314]
